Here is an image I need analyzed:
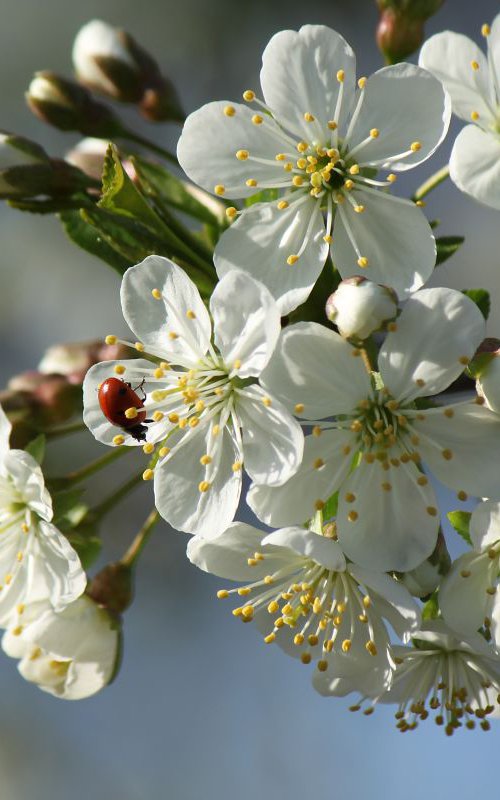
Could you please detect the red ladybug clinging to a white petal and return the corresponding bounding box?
[98,378,152,442]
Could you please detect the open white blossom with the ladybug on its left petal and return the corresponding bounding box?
[84,256,303,536]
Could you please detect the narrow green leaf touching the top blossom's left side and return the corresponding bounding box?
[131,156,222,230]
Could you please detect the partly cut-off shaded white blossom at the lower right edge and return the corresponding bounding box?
[439,500,500,648]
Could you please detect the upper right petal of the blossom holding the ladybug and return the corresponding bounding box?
[210,270,281,378]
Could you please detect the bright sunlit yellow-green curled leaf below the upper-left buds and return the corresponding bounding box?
[98,144,161,231]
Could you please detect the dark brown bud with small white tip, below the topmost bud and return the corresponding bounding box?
[26,72,123,139]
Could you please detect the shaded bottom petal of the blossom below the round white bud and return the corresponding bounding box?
[337,454,439,572]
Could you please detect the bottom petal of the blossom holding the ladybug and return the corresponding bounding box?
[154,425,241,539]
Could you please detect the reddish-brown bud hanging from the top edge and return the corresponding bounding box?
[376,0,443,64]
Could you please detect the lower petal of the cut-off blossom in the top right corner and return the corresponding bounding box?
[450,125,500,209]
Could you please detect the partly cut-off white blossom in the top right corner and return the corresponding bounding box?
[419,14,500,209]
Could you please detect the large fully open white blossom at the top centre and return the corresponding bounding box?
[177,25,450,314]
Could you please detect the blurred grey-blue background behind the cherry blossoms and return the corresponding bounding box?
[0,0,500,800]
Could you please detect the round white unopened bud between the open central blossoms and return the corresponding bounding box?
[326,275,398,339]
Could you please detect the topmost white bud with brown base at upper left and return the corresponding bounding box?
[73,19,184,122]
